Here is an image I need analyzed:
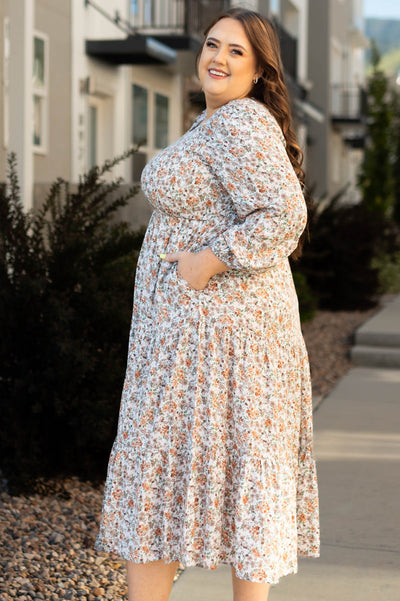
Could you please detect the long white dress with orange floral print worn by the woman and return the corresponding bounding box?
[95,98,319,583]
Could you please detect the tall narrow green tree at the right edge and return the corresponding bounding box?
[358,42,394,215]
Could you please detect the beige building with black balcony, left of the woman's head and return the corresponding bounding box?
[0,0,227,225]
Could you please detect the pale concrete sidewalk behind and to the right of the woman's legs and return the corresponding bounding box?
[171,297,400,601]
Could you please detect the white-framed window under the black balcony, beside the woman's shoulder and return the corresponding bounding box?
[132,84,170,182]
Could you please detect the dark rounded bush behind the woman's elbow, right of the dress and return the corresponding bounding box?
[295,195,399,310]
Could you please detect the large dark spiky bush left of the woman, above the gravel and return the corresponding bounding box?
[0,150,144,488]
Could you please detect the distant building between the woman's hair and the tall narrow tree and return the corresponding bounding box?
[307,0,369,202]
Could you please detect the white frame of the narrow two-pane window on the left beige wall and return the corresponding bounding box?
[32,30,50,154]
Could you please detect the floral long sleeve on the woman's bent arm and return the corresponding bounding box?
[206,98,307,270]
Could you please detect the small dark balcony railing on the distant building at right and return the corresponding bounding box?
[331,84,367,123]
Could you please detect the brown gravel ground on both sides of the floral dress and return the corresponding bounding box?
[0,309,382,601]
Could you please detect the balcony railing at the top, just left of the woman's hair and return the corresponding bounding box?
[130,0,230,36]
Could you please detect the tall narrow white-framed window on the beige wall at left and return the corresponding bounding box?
[32,34,48,152]
